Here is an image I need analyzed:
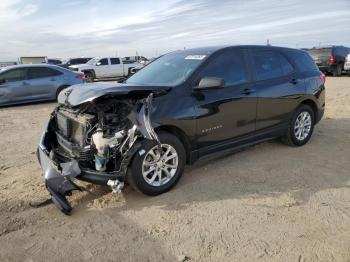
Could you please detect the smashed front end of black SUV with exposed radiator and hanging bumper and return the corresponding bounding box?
[38,92,160,214]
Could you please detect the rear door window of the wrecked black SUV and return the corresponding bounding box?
[253,50,294,80]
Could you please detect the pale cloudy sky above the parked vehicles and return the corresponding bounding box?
[0,0,350,61]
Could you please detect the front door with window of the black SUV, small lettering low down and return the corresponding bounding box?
[193,48,257,155]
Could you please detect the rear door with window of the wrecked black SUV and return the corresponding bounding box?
[251,49,305,130]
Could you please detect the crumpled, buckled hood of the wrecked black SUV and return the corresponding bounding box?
[58,82,169,107]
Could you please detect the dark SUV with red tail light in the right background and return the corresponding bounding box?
[309,46,350,76]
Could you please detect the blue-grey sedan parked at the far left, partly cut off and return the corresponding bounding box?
[0,64,84,106]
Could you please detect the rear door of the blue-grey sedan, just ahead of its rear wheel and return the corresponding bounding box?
[27,66,63,99]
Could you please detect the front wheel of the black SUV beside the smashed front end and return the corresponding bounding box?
[127,132,186,196]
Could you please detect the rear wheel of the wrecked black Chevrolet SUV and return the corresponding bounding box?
[282,105,315,146]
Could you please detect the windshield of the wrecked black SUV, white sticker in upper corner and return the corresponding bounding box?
[126,52,207,86]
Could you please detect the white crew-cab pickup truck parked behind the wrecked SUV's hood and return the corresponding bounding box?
[68,57,144,80]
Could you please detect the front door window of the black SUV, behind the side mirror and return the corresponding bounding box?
[200,50,248,86]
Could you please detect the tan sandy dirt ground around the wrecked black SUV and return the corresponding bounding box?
[0,77,350,261]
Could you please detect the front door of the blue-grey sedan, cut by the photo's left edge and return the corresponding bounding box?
[0,67,31,104]
